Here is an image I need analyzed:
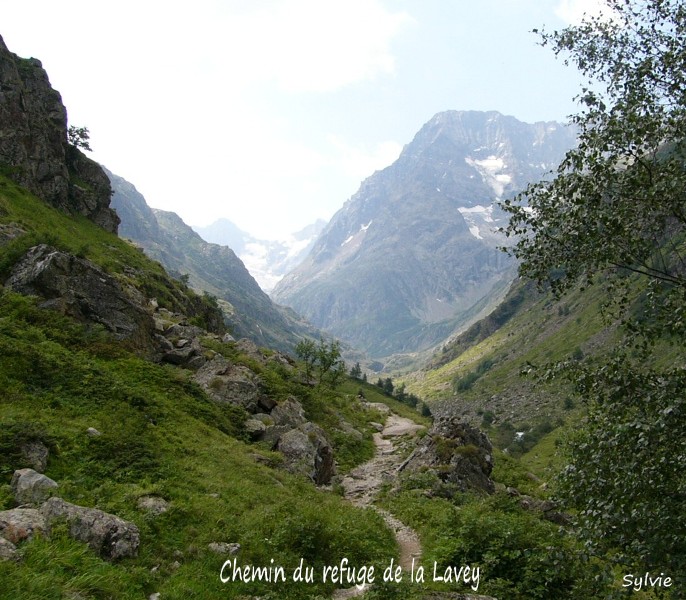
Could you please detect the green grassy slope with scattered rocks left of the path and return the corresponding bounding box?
[0,181,420,600]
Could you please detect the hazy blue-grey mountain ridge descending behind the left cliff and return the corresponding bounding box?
[105,169,318,351]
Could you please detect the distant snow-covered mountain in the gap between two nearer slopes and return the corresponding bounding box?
[193,219,326,293]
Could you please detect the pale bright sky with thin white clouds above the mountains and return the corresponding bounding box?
[0,0,601,239]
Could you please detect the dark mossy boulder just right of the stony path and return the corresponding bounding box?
[401,417,495,494]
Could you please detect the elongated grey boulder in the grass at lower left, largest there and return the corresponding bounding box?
[41,498,140,560]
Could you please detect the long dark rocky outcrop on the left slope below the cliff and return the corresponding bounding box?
[5,244,154,350]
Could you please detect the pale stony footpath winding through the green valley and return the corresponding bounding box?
[333,404,424,600]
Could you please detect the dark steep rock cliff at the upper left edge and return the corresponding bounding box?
[0,33,119,233]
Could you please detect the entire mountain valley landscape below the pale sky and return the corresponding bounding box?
[0,8,686,600]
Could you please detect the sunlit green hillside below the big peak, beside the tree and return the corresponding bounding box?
[407,281,628,454]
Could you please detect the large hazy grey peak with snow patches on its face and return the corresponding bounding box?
[272,111,574,357]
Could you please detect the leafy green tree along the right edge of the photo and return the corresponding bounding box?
[504,0,686,574]
